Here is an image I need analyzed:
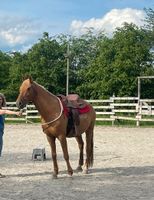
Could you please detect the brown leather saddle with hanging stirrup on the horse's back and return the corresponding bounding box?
[58,94,87,136]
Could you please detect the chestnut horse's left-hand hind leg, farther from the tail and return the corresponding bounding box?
[75,135,84,171]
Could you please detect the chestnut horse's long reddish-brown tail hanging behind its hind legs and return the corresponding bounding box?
[86,124,94,167]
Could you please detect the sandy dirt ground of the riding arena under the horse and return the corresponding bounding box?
[0,125,154,200]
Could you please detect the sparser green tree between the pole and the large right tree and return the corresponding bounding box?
[70,30,105,97]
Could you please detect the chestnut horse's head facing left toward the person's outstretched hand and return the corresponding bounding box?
[16,77,34,109]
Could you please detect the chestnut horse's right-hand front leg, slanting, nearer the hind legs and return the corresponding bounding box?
[58,135,73,176]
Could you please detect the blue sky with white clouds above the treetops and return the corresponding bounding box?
[0,0,154,51]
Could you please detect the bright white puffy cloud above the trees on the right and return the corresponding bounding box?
[70,8,145,35]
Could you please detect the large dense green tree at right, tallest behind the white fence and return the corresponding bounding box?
[80,23,154,98]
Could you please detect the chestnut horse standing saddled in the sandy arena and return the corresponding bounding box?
[16,77,96,178]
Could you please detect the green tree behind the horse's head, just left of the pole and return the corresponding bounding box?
[27,33,66,94]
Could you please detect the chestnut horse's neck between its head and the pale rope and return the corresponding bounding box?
[33,85,60,121]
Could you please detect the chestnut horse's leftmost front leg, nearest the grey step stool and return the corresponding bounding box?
[47,135,58,178]
